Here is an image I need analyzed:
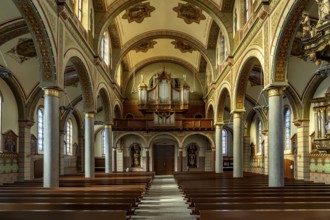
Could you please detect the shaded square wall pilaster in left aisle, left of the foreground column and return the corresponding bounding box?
[17,120,33,181]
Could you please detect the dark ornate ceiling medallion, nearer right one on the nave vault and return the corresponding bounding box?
[173,3,206,24]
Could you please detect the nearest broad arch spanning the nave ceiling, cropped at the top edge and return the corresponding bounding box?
[94,0,233,56]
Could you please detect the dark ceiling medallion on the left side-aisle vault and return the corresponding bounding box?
[7,38,37,63]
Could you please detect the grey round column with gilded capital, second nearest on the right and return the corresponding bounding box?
[233,111,243,178]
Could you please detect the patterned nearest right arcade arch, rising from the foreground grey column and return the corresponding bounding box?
[270,0,308,84]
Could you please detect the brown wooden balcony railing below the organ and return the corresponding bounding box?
[113,118,214,131]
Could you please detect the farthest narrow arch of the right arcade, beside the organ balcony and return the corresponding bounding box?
[215,82,231,123]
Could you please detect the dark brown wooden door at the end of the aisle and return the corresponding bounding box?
[153,145,174,175]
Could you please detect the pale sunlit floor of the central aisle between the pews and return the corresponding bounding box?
[132,176,196,220]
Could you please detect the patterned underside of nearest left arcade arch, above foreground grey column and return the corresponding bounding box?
[13,0,58,87]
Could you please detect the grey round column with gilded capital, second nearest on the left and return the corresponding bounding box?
[85,112,95,178]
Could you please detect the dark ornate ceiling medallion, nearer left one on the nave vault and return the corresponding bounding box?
[122,2,155,23]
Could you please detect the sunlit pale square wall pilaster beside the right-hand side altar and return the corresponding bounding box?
[294,120,310,181]
